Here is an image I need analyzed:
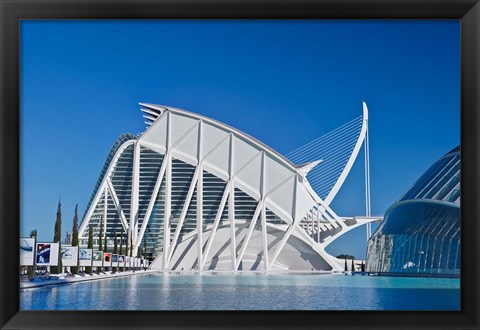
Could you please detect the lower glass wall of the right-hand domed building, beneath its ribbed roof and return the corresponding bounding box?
[366,200,460,275]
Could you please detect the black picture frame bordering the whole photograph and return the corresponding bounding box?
[0,0,480,329]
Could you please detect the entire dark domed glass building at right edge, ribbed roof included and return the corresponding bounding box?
[366,147,460,275]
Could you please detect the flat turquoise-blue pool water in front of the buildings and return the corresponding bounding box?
[20,274,460,310]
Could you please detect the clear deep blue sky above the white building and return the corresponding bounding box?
[20,20,460,258]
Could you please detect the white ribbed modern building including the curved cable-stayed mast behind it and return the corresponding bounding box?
[79,103,378,271]
